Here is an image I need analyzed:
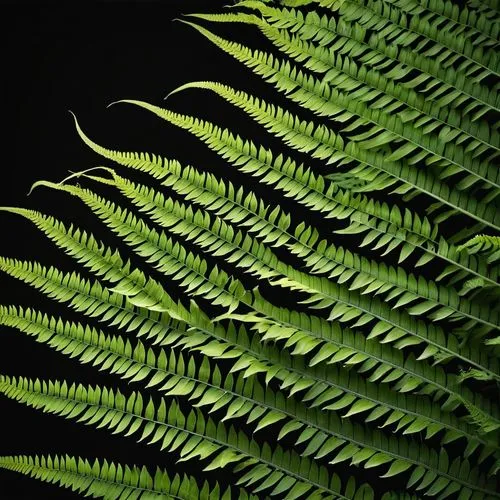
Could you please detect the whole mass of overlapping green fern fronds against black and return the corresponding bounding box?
[0,0,500,500]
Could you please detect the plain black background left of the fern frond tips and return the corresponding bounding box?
[0,0,284,500]
